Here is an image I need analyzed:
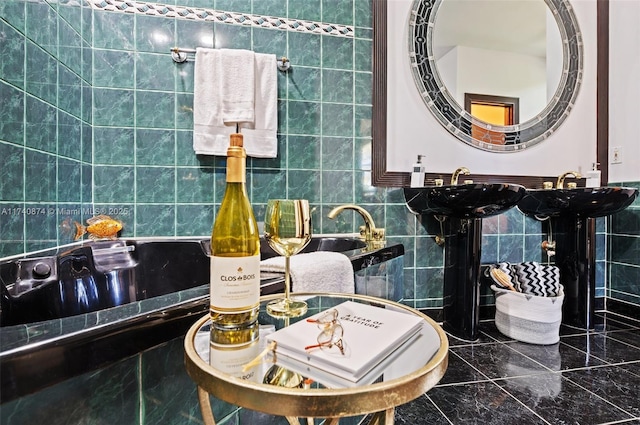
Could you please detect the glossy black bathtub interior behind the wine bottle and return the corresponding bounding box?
[0,237,366,326]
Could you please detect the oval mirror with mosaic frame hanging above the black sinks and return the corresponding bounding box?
[409,0,582,152]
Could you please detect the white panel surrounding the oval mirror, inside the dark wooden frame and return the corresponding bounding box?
[387,0,597,175]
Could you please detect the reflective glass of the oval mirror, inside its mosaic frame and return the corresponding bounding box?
[433,0,562,122]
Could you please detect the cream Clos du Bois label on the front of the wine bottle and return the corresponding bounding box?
[210,254,260,313]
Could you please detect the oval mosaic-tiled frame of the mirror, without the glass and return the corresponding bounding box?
[409,0,584,152]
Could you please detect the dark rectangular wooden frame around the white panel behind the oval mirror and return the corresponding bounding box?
[371,0,609,188]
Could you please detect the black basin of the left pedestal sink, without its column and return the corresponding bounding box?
[404,183,525,218]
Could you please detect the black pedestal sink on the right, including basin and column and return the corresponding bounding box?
[518,187,638,329]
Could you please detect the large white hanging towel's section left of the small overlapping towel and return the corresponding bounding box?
[193,47,236,156]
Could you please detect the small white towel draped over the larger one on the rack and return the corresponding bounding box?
[220,49,256,124]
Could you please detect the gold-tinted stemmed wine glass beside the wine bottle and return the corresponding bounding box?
[264,199,311,317]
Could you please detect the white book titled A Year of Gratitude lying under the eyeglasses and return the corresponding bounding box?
[267,301,423,382]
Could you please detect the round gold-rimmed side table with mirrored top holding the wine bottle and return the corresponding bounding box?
[184,293,449,425]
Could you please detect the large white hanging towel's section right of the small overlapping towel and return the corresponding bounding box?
[240,53,278,158]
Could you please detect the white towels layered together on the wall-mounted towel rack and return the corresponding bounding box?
[193,48,278,158]
